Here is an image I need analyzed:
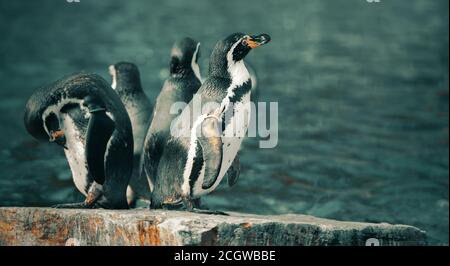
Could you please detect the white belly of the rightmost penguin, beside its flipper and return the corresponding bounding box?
[193,92,250,197]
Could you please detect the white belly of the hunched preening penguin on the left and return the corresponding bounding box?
[61,114,88,196]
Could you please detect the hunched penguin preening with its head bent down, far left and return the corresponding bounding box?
[24,73,133,209]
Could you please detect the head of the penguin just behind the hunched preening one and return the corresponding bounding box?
[109,62,142,94]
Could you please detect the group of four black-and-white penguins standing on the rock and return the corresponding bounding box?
[24,33,270,212]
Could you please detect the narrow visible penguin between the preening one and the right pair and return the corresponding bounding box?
[109,62,153,204]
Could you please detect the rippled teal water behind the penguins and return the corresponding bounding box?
[0,0,449,244]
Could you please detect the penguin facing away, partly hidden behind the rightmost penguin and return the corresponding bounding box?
[141,37,201,205]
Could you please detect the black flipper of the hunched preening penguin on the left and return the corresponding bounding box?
[86,110,115,184]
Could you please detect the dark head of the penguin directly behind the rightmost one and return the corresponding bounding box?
[170,37,200,80]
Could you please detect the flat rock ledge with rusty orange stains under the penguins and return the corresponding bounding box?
[0,208,426,246]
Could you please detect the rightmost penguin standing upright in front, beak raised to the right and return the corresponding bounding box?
[149,33,270,213]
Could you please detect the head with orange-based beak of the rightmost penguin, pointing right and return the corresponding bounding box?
[209,32,270,76]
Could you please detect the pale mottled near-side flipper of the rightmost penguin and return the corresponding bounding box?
[198,117,223,189]
